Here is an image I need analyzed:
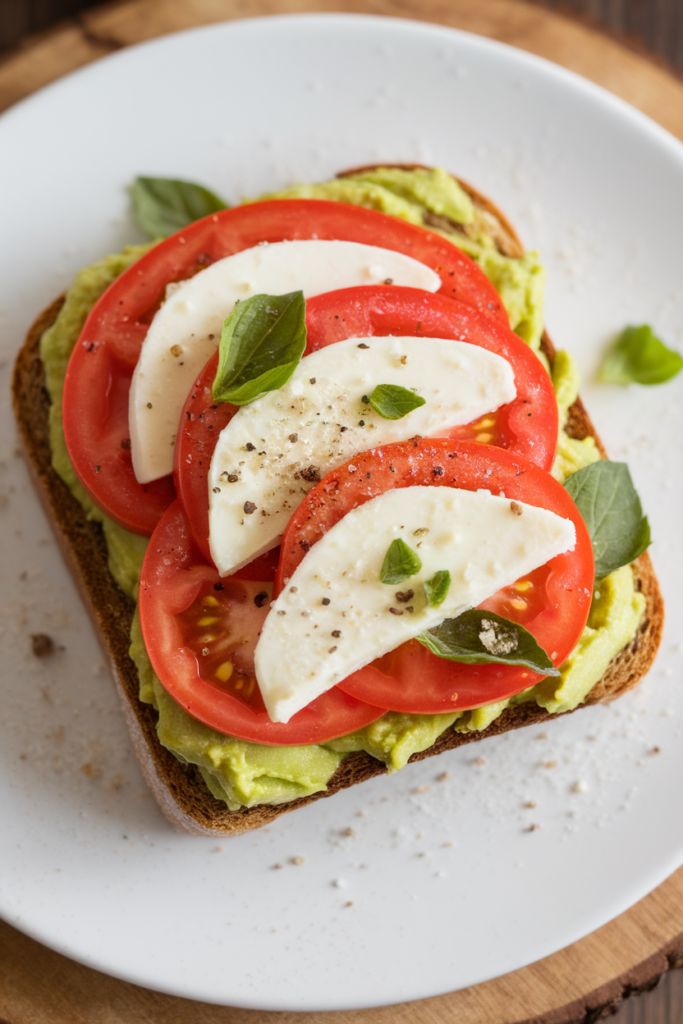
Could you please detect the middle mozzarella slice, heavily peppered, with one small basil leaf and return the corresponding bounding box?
[209,337,516,575]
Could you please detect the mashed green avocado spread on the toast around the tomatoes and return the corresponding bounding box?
[41,168,645,810]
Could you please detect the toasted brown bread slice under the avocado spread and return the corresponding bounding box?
[12,184,664,836]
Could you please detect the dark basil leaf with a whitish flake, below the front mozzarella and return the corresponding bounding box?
[417,608,560,676]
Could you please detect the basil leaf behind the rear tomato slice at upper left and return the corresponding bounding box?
[131,178,226,239]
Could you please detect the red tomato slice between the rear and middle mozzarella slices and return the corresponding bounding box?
[175,286,558,565]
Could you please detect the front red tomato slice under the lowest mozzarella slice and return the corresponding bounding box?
[275,439,594,714]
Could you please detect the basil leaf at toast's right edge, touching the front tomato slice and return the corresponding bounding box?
[564,459,650,580]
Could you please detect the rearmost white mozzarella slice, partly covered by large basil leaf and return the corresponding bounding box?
[128,239,441,483]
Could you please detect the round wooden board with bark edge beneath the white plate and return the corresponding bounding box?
[0,0,683,1024]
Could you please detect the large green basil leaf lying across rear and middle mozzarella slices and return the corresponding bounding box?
[213,292,306,406]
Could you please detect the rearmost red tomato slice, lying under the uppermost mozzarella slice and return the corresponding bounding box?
[63,200,507,535]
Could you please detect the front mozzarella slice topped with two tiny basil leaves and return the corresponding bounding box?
[255,486,575,722]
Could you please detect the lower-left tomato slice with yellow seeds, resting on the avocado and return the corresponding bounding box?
[139,502,384,745]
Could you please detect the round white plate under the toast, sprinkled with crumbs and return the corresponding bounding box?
[0,15,683,1010]
